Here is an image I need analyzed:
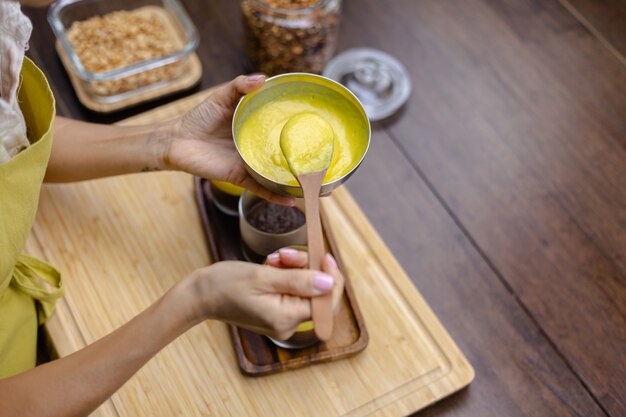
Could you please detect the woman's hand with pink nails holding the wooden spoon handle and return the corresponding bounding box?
[190,254,343,340]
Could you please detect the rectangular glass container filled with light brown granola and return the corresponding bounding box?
[48,0,198,104]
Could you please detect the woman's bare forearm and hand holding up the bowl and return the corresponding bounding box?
[45,75,296,198]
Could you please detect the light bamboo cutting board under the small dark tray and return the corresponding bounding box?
[27,86,474,416]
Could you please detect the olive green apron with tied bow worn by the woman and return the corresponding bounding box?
[0,58,63,378]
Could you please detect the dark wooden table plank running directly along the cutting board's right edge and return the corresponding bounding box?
[348,128,605,417]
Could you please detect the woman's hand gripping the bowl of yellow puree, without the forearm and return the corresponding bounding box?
[165,75,295,205]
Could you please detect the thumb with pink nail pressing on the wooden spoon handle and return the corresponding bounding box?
[264,267,335,297]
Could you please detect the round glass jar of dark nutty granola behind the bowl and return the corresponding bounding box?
[241,0,341,75]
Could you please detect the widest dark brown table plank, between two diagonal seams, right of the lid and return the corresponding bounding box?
[334,0,626,415]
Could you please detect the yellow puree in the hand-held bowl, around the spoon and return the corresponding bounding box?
[237,93,368,185]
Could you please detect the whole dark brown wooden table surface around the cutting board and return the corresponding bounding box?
[26,0,626,417]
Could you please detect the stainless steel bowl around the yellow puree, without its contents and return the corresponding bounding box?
[232,73,372,197]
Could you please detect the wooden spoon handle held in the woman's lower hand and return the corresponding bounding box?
[298,170,333,341]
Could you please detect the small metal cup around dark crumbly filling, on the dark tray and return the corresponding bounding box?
[239,191,307,263]
